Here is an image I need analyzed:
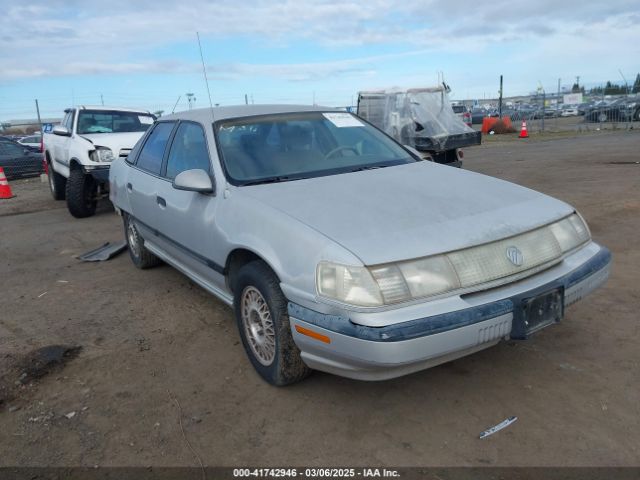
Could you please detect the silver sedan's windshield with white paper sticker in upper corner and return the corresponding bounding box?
[215,112,416,185]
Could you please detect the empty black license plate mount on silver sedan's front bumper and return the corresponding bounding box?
[511,287,564,338]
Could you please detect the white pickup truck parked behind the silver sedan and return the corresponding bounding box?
[44,106,155,218]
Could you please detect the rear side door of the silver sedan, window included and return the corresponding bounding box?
[124,122,177,247]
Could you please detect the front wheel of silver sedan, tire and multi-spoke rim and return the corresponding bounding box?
[233,260,311,386]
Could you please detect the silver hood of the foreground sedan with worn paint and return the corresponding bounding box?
[239,162,573,265]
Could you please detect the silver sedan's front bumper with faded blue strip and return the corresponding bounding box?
[288,247,611,380]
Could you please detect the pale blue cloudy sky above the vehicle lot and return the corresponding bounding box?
[0,0,640,120]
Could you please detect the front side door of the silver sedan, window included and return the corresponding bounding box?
[156,121,225,290]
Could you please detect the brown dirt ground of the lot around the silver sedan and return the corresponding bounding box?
[0,131,640,466]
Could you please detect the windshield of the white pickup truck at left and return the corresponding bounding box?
[78,110,155,135]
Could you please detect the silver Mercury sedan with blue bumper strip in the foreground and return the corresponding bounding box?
[109,105,611,385]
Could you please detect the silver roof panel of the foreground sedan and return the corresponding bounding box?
[160,105,344,123]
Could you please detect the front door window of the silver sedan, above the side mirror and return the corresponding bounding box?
[165,122,210,179]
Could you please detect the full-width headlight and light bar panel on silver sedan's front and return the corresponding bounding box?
[316,213,591,307]
